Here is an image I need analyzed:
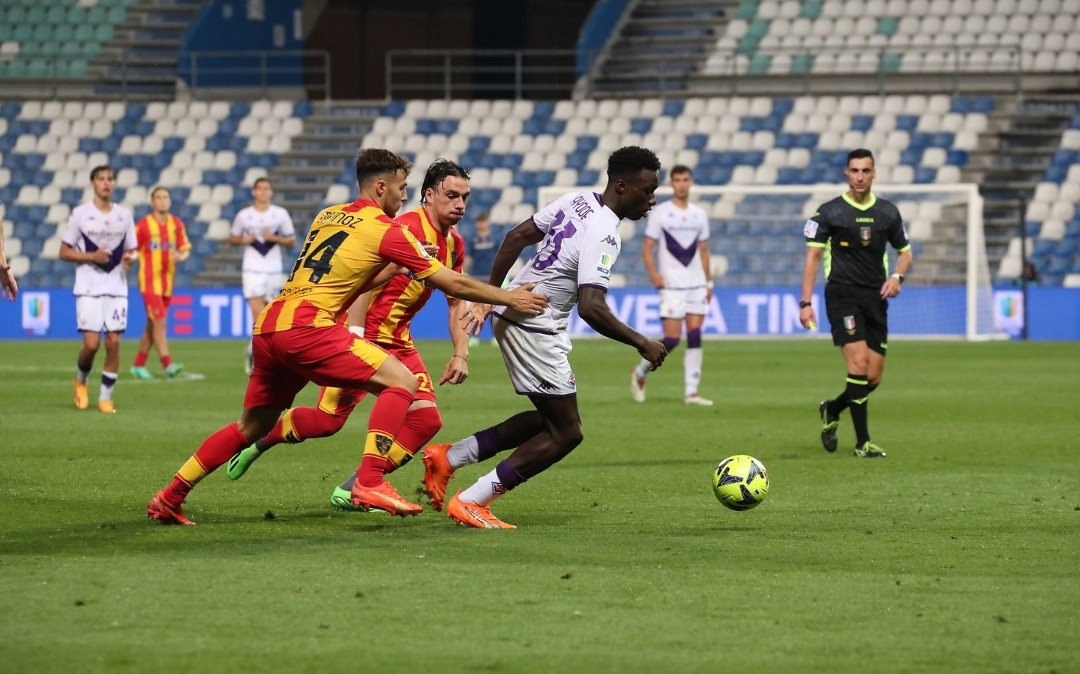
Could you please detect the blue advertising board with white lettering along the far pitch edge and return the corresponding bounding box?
[0,286,1080,340]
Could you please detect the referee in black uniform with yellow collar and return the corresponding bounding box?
[799,149,912,458]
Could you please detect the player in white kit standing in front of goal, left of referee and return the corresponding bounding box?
[630,164,713,406]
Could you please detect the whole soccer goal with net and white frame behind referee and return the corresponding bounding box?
[538,184,1002,340]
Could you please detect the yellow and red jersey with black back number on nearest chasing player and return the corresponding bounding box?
[253,199,443,335]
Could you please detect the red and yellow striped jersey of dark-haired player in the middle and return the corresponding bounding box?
[364,206,465,348]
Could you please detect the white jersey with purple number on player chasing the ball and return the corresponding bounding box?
[496,192,622,333]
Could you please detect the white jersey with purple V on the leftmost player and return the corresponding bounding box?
[60,201,138,297]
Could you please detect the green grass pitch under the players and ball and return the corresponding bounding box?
[0,340,1080,674]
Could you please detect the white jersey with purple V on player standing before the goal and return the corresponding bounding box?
[645,201,708,289]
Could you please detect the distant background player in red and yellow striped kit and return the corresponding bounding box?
[132,187,191,379]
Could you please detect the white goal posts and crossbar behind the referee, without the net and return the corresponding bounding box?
[537,183,1001,341]
